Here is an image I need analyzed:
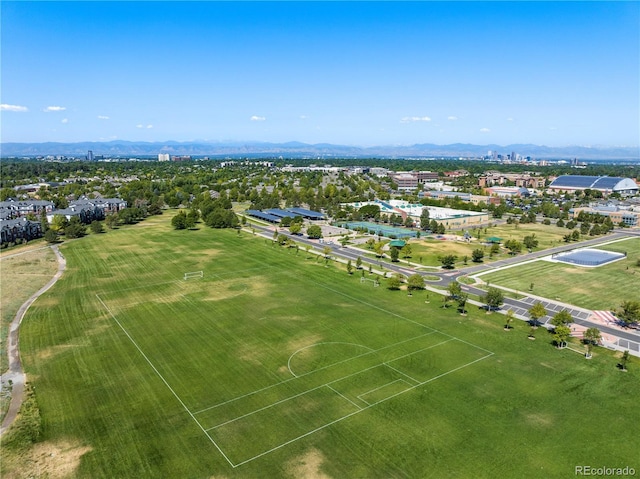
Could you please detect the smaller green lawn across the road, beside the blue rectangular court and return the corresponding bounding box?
[481,238,640,310]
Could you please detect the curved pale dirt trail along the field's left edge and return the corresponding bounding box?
[0,245,67,435]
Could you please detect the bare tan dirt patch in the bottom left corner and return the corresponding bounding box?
[4,442,91,479]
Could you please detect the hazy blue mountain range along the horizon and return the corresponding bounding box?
[0,140,640,160]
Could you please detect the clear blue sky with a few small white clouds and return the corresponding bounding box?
[0,0,640,146]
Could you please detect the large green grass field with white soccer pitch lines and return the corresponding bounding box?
[0,215,640,478]
